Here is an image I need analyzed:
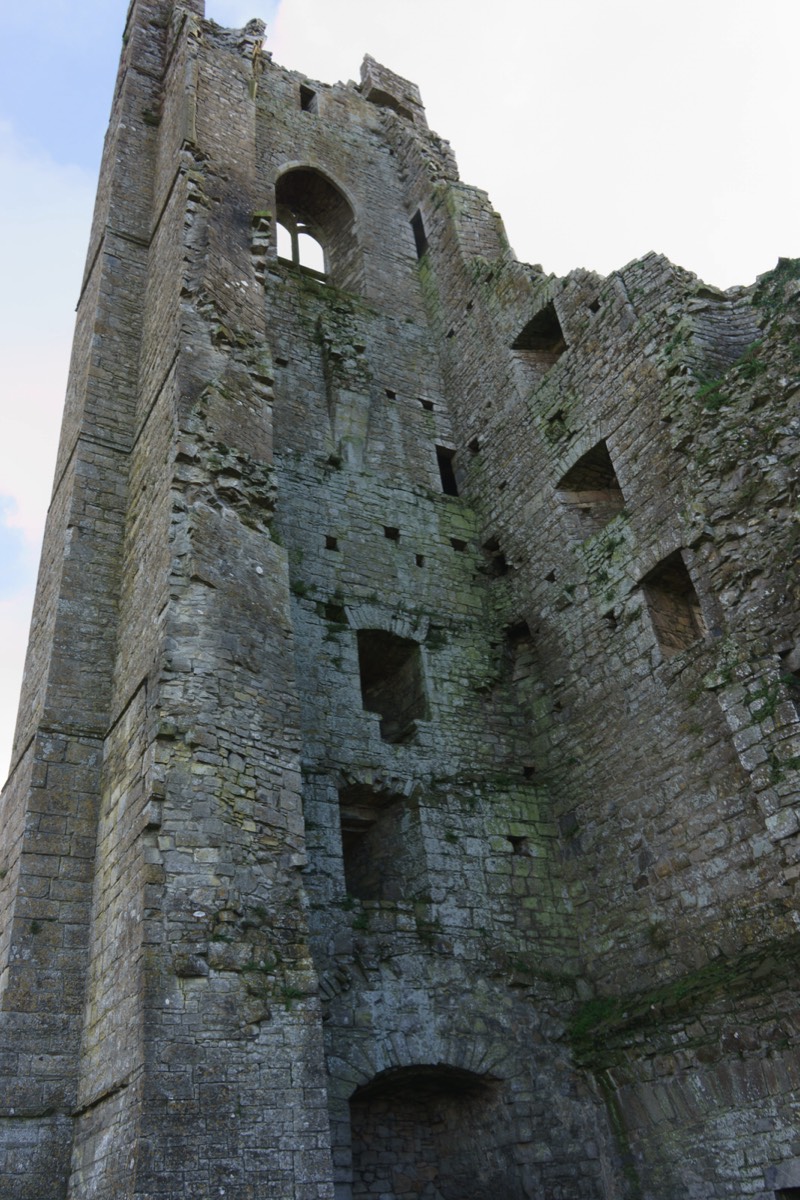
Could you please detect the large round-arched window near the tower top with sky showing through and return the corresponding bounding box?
[275,167,361,292]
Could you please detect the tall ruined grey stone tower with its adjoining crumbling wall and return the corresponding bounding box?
[0,0,800,1200]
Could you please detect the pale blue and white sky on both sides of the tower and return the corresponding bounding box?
[0,0,800,778]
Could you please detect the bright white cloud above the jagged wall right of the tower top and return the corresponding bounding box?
[267,0,800,286]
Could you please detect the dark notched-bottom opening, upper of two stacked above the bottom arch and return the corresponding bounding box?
[357,629,427,742]
